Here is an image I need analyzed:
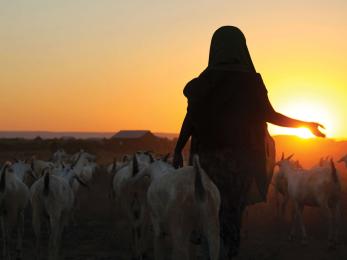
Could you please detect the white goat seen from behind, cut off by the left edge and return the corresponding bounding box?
[0,163,29,259]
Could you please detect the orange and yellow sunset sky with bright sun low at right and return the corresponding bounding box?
[0,0,347,139]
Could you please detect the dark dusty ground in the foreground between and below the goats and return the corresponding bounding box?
[6,169,347,260]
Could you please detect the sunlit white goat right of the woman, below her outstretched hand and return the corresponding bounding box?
[277,155,341,246]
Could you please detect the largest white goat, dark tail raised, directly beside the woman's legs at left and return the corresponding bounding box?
[147,156,220,260]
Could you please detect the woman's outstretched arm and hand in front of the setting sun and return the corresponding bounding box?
[265,100,325,137]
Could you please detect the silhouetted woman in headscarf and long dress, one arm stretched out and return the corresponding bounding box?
[174,26,324,259]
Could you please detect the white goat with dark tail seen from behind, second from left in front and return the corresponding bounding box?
[30,168,74,260]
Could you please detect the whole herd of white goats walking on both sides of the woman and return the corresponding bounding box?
[0,149,347,260]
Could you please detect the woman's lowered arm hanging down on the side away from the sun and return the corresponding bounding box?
[173,113,193,168]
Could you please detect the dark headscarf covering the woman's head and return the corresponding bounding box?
[207,26,255,72]
